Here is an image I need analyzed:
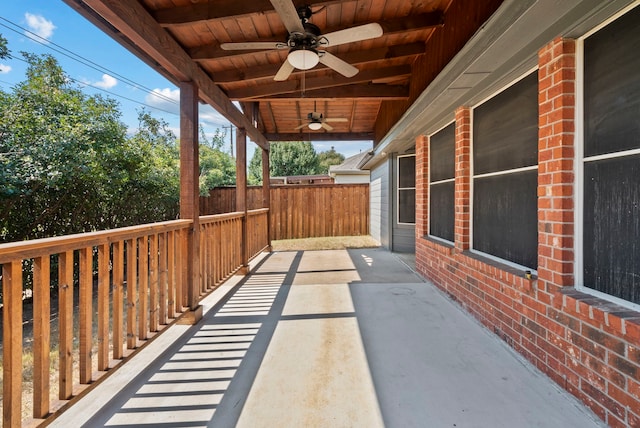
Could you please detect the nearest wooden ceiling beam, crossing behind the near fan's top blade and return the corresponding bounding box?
[152,0,343,27]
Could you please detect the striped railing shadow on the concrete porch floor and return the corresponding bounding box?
[77,252,302,428]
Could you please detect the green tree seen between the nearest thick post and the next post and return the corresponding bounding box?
[200,129,236,196]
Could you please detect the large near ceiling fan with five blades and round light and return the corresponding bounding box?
[220,0,383,81]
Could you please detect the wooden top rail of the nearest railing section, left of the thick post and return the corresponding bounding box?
[0,219,192,264]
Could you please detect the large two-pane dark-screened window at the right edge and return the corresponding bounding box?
[578,7,640,304]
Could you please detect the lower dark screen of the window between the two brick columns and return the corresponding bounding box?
[473,170,538,269]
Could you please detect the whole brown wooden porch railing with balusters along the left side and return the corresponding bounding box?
[0,209,268,427]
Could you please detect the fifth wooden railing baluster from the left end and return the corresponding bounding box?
[97,244,110,371]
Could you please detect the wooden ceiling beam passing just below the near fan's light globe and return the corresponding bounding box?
[213,42,425,83]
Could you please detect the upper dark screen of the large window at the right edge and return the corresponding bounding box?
[584,7,640,156]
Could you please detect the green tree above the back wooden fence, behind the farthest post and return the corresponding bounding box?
[248,141,320,184]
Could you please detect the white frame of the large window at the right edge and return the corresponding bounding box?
[573,2,640,311]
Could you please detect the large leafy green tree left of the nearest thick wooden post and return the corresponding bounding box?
[0,53,179,242]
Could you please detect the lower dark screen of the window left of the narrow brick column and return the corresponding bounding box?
[429,181,455,242]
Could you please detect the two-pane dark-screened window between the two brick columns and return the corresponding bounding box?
[472,72,538,270]
